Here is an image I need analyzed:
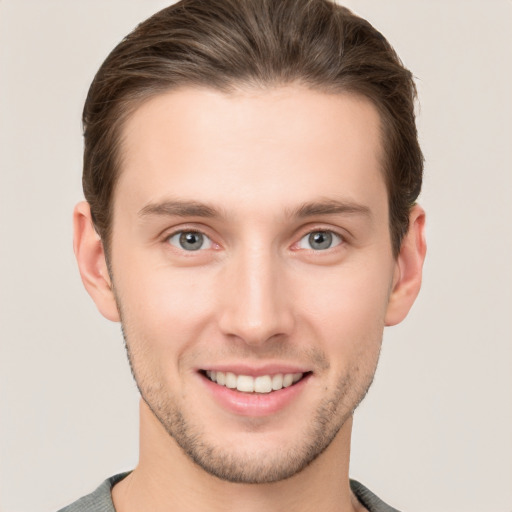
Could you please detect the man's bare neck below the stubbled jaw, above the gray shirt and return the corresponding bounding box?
[112,401,360,512]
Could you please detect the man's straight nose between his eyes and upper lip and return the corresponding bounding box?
[219,249,294,345]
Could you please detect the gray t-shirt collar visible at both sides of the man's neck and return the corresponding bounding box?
[59,472,398,512]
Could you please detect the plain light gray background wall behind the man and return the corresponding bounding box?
[0,0,512,512]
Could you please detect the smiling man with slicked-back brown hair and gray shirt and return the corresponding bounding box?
[64,0,425,512]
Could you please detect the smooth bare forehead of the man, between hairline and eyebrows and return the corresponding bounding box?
[114,86,386,216]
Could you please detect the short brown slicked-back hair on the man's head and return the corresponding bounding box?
[83,0,423,255]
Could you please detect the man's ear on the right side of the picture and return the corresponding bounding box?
[385,205,427,326]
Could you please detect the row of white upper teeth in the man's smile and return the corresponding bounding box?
[206,370,304,393]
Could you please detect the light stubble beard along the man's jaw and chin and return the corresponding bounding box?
[123,328,378,484]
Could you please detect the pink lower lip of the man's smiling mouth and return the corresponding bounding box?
[200,374,311,417]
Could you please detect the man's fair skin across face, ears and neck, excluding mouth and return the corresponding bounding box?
[74,86,425,512]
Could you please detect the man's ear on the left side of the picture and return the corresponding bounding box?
[73,201,119,322]
